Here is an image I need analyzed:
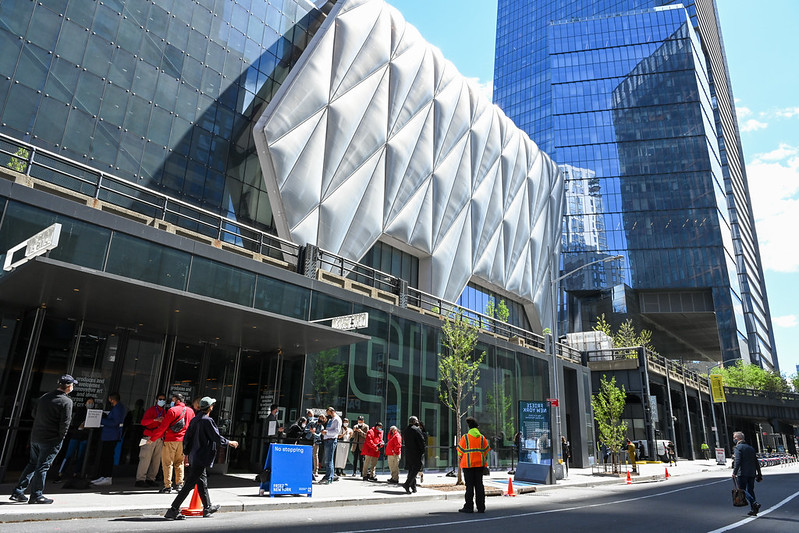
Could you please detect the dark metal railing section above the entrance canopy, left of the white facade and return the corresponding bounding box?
[0,133,300,270]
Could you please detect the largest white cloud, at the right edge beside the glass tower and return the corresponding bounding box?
[746,144,799,272]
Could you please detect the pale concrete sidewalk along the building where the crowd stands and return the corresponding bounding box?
[0,460,729,523]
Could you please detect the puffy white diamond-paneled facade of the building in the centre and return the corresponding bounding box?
[255,0,563,328]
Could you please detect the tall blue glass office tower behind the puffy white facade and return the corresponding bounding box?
[494,0,779,369]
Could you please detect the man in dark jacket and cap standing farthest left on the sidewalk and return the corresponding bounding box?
[9,374,78,504]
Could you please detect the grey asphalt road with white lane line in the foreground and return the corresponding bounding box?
[7,467,799,533]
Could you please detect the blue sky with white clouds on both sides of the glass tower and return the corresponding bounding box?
[388,0,799,375]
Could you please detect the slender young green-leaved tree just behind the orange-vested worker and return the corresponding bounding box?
[438,312,485,485]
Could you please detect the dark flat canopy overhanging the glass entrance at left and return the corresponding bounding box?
[0,257,370,354]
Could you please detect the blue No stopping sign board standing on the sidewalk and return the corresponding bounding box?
[261,444,313,498]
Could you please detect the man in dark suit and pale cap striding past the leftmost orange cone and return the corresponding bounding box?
[164,396,239,520]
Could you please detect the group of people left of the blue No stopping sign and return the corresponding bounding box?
[10,374,238,519]
